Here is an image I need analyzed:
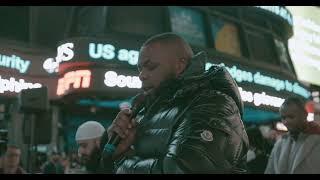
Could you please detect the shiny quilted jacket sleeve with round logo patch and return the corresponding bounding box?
[117,90,248,173]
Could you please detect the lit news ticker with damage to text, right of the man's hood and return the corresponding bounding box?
[205,55,311,112]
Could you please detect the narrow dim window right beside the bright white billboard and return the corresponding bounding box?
[274,39,294,73]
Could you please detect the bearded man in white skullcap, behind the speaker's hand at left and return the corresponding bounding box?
[75,121,105,173]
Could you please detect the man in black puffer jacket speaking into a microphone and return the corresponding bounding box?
[106,33,248,174]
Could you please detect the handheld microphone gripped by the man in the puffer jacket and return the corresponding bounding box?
[103,93,145,157]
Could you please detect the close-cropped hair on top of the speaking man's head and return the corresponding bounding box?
[141,32,193,61]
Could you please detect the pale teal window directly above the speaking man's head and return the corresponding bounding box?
[169,6,206,47]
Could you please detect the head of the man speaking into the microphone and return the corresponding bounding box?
[138,33,193,94]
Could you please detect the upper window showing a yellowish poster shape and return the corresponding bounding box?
[211,17,242,57]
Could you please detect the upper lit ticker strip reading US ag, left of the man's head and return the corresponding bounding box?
[43,38,140,74]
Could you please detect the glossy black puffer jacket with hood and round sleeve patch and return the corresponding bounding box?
[115,51,248,173]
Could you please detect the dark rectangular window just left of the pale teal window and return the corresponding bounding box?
[107,6,164,36]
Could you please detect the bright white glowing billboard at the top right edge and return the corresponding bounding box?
[287,6,320,85]
